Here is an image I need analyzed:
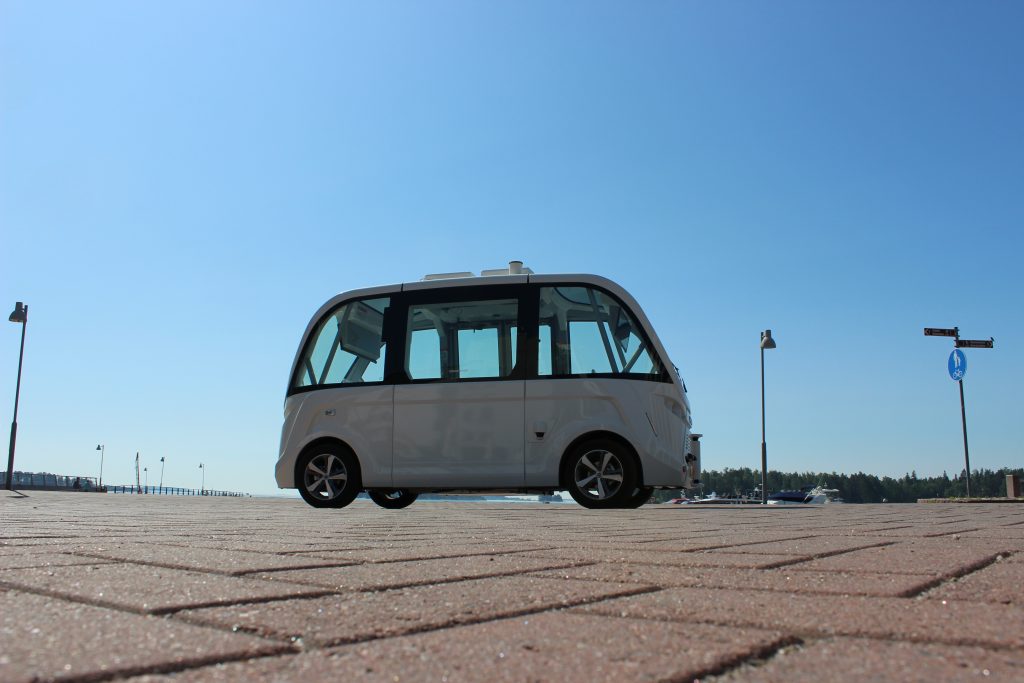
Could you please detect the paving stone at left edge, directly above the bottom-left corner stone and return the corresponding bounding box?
[0,563,323,613]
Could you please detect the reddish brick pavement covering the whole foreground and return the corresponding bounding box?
[0,492,1024,683]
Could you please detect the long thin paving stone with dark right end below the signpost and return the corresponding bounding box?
[535,562,935,597]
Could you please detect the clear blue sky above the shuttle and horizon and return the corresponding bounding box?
[0,0,1024,493]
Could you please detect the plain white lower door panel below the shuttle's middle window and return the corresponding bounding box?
[394,380,523,488]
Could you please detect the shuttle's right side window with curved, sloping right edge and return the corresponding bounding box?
[538,287,662,377]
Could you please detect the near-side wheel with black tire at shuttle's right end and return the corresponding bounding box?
[562,438,640,510]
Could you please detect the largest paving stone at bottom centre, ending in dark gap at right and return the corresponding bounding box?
[133,612,785,683]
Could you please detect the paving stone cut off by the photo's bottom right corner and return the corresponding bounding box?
[715,638,1024,683]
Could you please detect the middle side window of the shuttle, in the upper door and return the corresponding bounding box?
[406,299,519,380]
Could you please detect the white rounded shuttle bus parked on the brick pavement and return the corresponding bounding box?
[276,261,700,508]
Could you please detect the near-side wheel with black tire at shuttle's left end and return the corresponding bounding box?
[295,443,362,508]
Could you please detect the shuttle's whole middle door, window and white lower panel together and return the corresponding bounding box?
[392,286,525,488]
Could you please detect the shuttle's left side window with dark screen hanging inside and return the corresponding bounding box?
[292,297,390,387]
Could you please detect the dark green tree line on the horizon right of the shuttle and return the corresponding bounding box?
[655,467,1024,503]
